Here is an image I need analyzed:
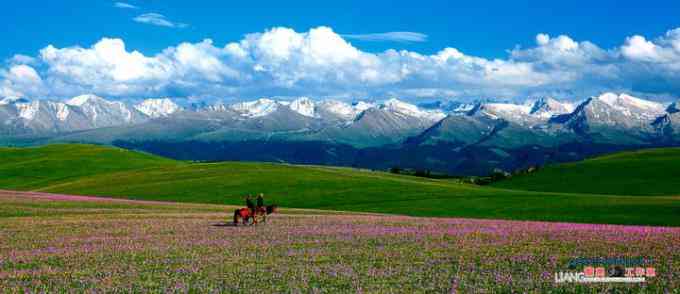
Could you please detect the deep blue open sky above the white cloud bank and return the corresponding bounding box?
[5,0,680,58]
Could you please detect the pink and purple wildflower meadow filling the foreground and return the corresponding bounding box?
[0,194,680,293]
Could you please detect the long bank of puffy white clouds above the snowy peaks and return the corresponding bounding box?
[0,27,680,99]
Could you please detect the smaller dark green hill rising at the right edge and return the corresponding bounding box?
[493,148,680,196]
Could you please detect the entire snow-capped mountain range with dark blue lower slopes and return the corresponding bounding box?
[0,93,680,174]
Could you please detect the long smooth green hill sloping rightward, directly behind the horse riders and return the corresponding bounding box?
[0,145,680,226]
